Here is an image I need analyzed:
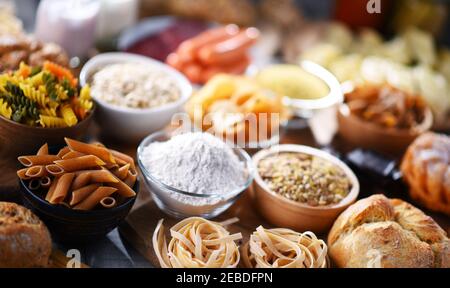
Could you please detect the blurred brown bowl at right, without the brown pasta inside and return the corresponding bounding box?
[338,104,433,157]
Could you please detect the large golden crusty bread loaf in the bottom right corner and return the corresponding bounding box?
[328,195,450,268]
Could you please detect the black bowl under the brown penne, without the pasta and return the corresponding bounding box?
[19,147,140,243]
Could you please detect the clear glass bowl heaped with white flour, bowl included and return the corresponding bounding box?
[137,131,254,218]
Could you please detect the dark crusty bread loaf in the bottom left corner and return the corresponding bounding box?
[0,202,52,268]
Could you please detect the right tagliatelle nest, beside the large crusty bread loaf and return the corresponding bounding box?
[242,226,328,268]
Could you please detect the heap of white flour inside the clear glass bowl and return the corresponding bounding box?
[141,132,247,206]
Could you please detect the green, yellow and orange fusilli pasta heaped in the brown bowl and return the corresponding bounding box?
[0,62,93,128]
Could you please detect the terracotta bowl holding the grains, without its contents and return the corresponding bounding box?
[253,145,359,233]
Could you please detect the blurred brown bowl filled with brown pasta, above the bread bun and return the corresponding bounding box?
[338,83,433,157]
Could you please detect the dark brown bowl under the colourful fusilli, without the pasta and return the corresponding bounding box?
[0,107,95,160]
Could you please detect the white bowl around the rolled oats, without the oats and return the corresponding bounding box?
[80,52,192,142]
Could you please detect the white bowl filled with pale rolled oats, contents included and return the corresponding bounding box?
[80,52,192,142]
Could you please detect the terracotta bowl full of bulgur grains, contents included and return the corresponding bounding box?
[253,145,359,233]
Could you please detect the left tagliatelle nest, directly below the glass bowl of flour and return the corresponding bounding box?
[153,217,242,268]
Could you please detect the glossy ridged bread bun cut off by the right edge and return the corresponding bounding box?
[401,132,450,215]
